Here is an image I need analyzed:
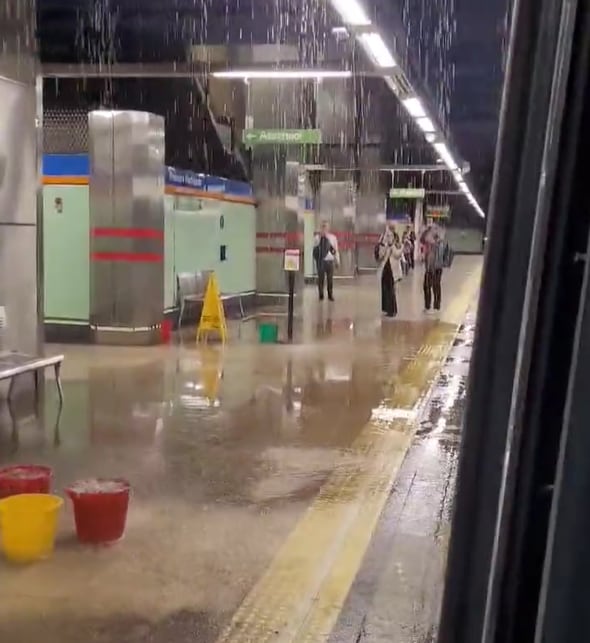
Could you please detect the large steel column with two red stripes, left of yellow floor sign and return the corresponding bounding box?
[88,111,165,345]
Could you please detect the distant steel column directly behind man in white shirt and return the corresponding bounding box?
[316,180,357,277]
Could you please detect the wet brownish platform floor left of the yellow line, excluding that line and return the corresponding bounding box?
[0,257,479,643]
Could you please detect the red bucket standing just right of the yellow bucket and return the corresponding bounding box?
[65,478,131,545]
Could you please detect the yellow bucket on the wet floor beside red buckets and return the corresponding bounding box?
[0,493,63,563]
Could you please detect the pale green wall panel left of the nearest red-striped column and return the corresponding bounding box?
[43,185,90,321]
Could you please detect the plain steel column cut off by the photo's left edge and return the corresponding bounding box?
[0,0,42,353]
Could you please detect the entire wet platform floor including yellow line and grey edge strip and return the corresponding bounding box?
[0,257,481,643]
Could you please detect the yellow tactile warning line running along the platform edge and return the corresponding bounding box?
[219,268,481,643]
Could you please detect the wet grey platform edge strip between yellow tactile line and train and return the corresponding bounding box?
[330,312,475,643]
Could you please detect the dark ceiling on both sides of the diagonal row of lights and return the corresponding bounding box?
[38,0,509,208]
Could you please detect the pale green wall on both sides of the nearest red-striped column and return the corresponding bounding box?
[43,185,256,321]
